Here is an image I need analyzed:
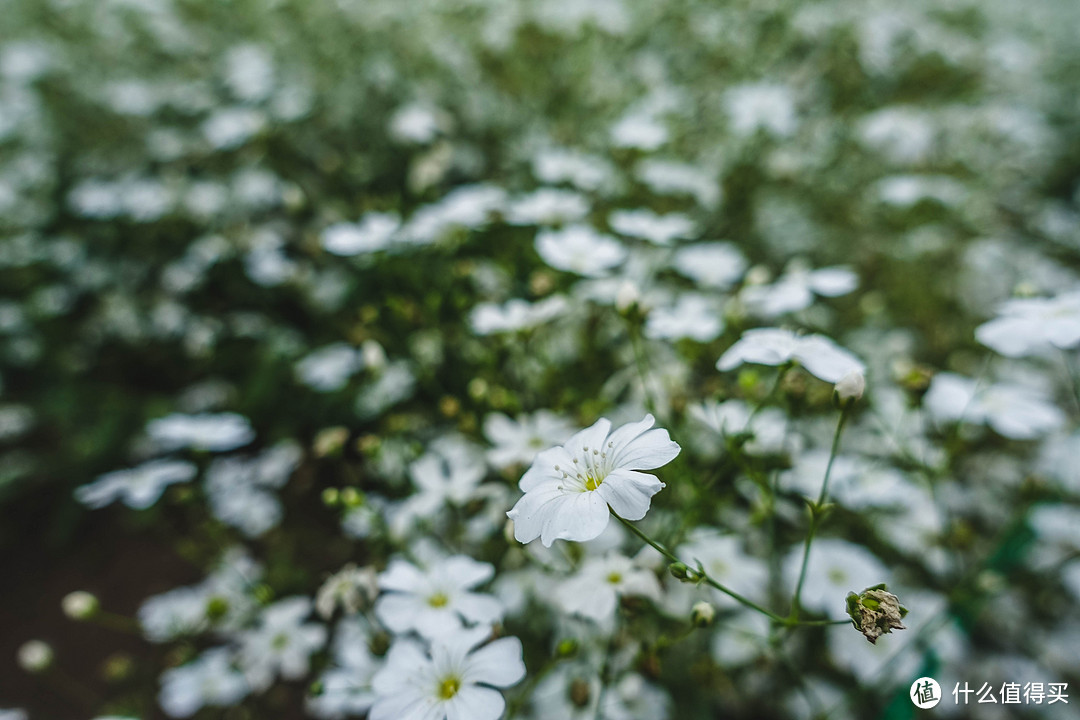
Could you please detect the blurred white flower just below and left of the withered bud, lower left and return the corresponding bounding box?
[239,597,326,691]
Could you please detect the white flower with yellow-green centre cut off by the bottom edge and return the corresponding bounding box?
[368,628,525,720]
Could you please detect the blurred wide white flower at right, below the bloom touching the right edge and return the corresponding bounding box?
[922,372,1065,440]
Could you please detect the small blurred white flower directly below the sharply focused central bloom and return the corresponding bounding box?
[555,554,660,623]
